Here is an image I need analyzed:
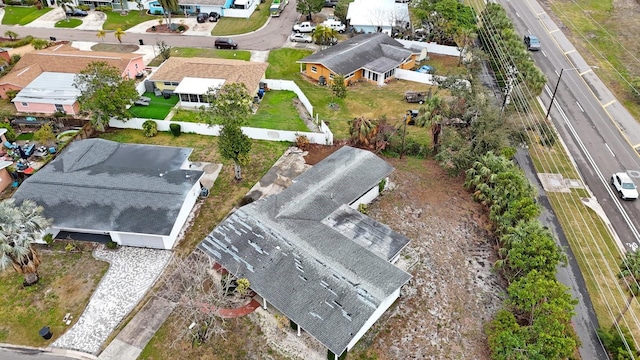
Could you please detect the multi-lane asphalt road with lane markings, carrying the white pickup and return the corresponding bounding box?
[502,1,640,250]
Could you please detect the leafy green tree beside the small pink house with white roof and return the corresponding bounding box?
[73,62,139,131]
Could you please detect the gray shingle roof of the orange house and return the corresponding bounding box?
[298,33,412,75]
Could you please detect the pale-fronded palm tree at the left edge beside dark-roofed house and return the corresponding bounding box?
[0,199,51,286]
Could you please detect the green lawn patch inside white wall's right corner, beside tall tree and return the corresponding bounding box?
[249,91,309,131]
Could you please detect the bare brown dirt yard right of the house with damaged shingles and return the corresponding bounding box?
[305,147,503,359]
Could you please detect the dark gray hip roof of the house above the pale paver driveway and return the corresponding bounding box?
[14,139,202,236]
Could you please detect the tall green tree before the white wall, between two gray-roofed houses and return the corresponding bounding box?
[200,83,253,180]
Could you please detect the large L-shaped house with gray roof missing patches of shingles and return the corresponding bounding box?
[198,146,411,357]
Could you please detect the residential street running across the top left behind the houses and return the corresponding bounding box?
[0,0,298,50]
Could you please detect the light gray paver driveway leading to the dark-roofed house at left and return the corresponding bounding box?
[52,246,173,354]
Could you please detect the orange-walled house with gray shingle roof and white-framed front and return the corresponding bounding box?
[297,33,420,85]
